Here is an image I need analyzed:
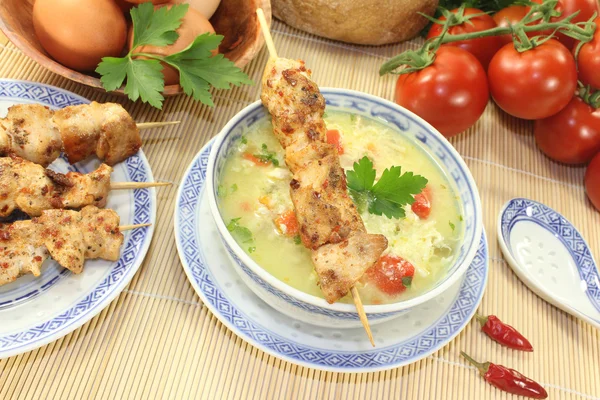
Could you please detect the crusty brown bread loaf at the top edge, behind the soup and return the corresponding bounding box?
[271,0,438,45]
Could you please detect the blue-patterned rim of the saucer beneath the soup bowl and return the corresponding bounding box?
[174,142,488,372]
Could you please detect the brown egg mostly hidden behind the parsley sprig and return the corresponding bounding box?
[128,5,215,85]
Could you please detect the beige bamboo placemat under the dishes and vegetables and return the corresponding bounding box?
[0,21,600,399]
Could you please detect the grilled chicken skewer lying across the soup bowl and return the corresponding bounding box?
[257,9,387,346]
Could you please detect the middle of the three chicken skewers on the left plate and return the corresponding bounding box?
[0,157,170,217]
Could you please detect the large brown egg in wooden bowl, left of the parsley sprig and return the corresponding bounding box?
[33,0,127,71]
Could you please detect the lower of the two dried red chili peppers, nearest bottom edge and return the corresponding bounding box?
[460,351,548,399]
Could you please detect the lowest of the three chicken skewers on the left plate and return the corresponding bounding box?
[0,206,147,286]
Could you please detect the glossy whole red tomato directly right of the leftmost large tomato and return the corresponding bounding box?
[488,39,577,119]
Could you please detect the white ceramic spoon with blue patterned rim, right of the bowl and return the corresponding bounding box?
[498,198,600,329]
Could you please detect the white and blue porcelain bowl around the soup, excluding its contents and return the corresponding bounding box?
[206,88,483,328]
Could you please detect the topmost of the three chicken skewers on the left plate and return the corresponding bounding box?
[0,102,179,167]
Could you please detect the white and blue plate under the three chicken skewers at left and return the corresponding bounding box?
[0,79,156,358]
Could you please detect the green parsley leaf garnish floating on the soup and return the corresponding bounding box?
[346,156,427,219]
